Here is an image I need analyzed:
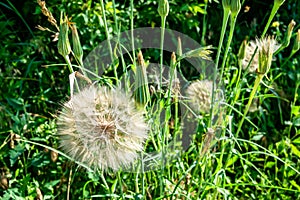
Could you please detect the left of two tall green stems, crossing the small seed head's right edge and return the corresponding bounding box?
[208,9,230,127]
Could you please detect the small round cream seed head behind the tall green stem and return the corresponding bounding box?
[186,80,213,113]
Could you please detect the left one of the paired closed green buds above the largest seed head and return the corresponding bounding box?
[57,15,71,57]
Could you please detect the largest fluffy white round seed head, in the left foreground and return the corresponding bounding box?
[58,86,148,170]
